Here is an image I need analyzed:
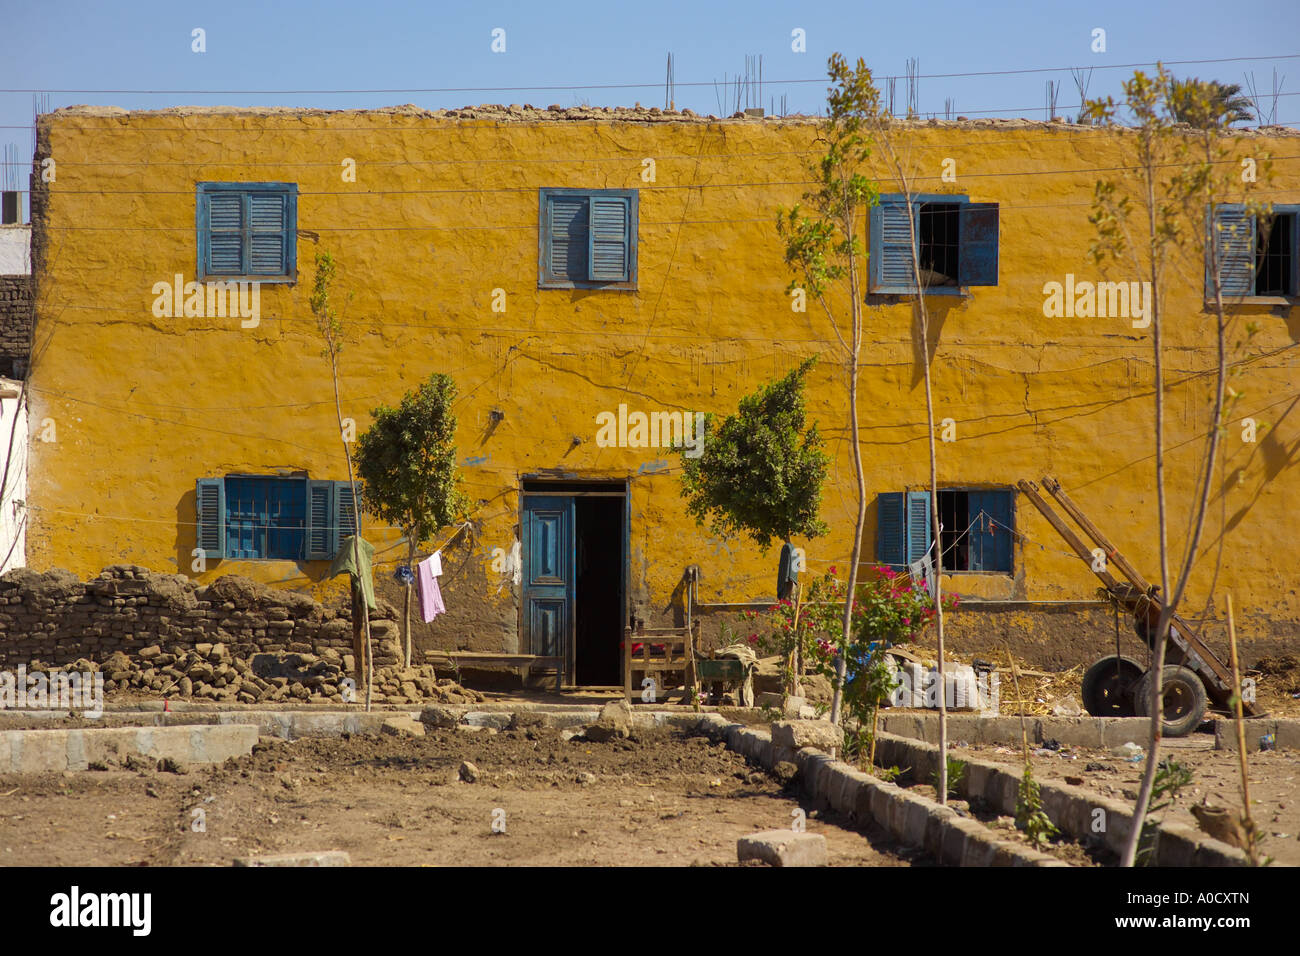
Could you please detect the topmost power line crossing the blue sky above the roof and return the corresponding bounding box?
[0,53,1300,94]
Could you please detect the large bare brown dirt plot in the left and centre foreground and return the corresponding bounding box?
[0,727,927,866]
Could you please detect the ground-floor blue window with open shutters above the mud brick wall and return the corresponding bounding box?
[195,475,356,561]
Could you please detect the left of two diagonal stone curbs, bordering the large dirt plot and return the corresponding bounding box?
[697,714,1069,866]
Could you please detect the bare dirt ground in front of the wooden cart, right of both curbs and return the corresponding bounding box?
[946,735,1300,866]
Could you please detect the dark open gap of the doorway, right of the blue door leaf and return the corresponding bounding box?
[573,494,624,687]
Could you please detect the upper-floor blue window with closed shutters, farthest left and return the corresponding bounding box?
[195,182,298,282]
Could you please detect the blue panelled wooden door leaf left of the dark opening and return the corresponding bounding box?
[521,494,575,675]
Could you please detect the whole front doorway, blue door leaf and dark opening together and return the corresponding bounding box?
[520,480,628,687]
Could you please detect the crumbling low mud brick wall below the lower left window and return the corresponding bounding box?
[0,564,398,669]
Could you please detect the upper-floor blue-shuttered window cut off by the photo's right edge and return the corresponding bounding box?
[1205,204,1300,299]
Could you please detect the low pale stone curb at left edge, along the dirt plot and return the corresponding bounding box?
[0,723,259,774]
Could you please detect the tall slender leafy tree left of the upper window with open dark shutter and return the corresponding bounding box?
[776,53,880,723]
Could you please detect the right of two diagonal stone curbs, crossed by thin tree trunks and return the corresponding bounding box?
[876,734,1248,866]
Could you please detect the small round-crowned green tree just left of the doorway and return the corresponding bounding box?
[354,373,468,667]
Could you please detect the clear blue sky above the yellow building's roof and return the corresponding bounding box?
[0,0,1300,197]
